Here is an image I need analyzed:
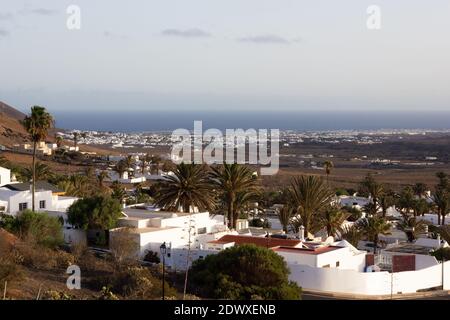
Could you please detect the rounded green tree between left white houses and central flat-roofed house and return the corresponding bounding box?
[67,196,122,230]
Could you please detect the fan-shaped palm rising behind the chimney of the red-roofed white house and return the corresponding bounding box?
[289,176,334,235]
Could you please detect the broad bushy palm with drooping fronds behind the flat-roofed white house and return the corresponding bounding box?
[155,163,214,212]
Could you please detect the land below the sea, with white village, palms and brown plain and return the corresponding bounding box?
[0,103,450,300]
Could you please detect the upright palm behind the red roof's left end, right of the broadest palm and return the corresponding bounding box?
[211,163,259,229]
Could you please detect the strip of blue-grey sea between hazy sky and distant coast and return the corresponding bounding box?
[53,111,450,132]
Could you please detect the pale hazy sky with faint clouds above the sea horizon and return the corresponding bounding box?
[0,0,450,111]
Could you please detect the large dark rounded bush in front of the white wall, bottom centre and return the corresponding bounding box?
[190,245,301,300]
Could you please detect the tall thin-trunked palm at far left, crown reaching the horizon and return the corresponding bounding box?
[22,106,54,211]
